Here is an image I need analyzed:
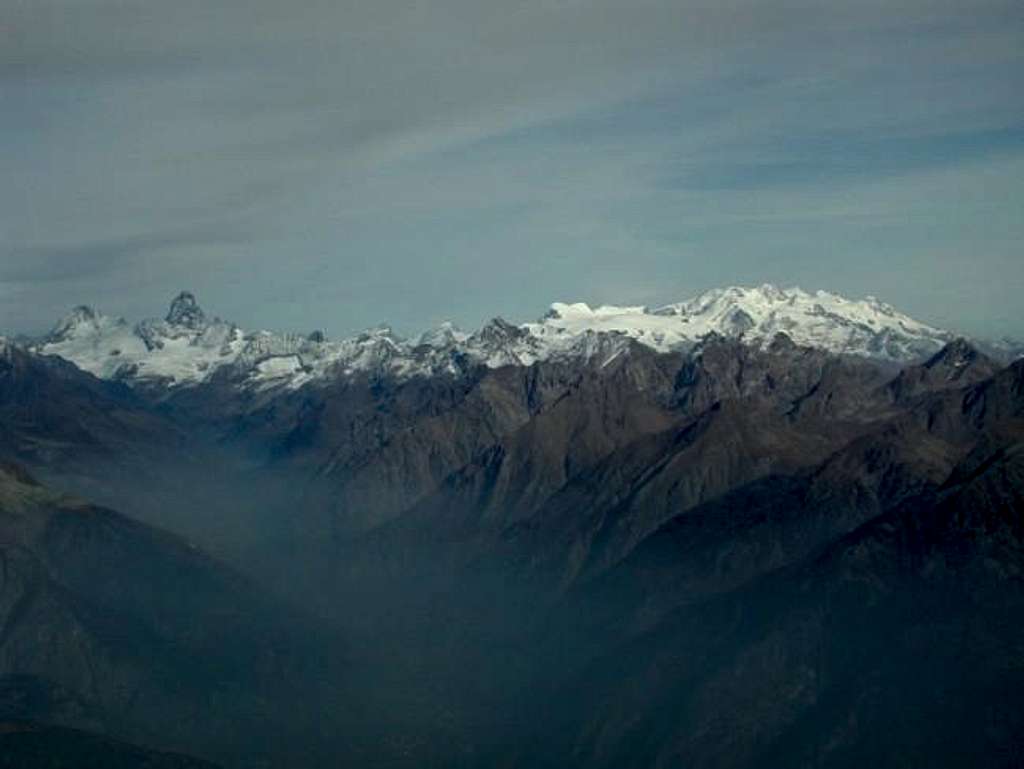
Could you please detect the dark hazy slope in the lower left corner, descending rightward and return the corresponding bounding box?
[0,468,342,766]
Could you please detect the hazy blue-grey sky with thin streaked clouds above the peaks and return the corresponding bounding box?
[0,0,1024,338]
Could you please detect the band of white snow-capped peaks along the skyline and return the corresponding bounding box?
[35,286,954,388]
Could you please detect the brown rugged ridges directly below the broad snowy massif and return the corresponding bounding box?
[343,337,905,602]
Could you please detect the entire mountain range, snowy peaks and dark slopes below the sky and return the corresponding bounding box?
[0,286,1024,769]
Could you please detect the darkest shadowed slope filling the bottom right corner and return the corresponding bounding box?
[516,444,1024,767]
